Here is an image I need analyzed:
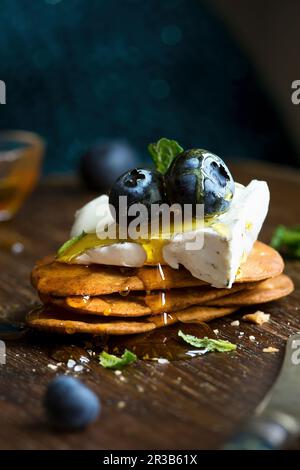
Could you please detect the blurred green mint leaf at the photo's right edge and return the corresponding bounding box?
[271,225,300,258]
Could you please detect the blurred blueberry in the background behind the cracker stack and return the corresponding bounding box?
[79,141,140,193]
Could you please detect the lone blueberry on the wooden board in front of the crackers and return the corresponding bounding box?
[44,375,101,429]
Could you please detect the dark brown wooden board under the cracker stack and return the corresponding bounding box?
[0,162,300,449]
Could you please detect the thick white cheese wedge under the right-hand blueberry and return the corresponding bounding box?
[163,180,270,288]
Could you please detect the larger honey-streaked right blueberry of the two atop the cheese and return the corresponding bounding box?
[165,149,234,216]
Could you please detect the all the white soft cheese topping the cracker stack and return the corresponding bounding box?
[71,180,269,288]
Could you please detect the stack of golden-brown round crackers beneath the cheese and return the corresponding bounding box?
[27,241,294,335]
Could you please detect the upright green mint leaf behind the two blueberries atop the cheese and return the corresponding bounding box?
[148,137,183,174]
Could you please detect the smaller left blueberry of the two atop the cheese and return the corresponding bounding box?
[109,168,166,222]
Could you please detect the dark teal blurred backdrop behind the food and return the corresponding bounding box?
[0,0,294,171]
